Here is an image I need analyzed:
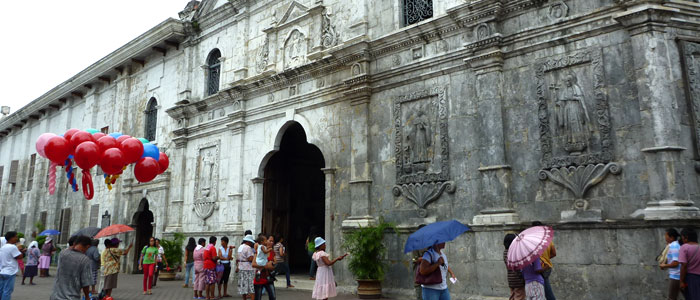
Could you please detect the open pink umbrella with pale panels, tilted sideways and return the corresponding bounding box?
[506,226,554,270]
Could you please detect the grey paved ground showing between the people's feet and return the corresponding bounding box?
[12,270,394,300]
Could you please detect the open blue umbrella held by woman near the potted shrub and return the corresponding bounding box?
[403,220,469,253]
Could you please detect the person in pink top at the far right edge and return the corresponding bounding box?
[678,228,700,300]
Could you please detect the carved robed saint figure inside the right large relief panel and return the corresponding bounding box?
[555,74,590,155]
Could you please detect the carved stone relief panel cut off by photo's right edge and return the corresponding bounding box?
[680,41,700,173]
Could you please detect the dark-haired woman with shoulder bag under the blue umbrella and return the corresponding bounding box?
[416,243,457,300]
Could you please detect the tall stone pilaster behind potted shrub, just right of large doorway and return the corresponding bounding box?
[343,60,375,227]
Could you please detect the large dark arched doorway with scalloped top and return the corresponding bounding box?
[262,123,326,272]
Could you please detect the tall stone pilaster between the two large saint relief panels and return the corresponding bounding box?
[465,31,520,225]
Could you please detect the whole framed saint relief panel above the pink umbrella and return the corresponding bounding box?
[535,48,620,214]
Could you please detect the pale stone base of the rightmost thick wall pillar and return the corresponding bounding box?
[631,200,700,220]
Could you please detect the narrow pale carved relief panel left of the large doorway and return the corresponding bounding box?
[192,140,221,225]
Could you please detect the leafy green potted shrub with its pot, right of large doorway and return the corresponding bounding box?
[343,219,394,299]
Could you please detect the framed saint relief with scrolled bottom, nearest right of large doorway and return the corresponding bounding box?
[392,87,456,217]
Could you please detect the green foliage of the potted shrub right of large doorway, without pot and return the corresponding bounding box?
[343,219,394,280]
